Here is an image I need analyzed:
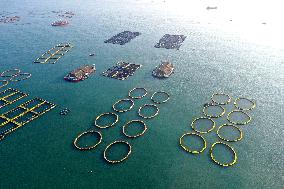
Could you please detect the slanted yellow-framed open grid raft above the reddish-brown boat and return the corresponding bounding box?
[34,43,73,64]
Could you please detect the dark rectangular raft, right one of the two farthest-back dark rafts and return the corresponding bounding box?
[155,34,186,50]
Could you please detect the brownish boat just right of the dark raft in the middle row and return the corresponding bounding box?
[152,61,174,78]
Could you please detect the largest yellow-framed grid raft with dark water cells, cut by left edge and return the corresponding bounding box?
[0,98,56,141]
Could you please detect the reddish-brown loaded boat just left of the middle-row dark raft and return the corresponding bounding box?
[64,64,96,82]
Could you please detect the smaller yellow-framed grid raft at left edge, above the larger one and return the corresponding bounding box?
[0,88,29,108]
